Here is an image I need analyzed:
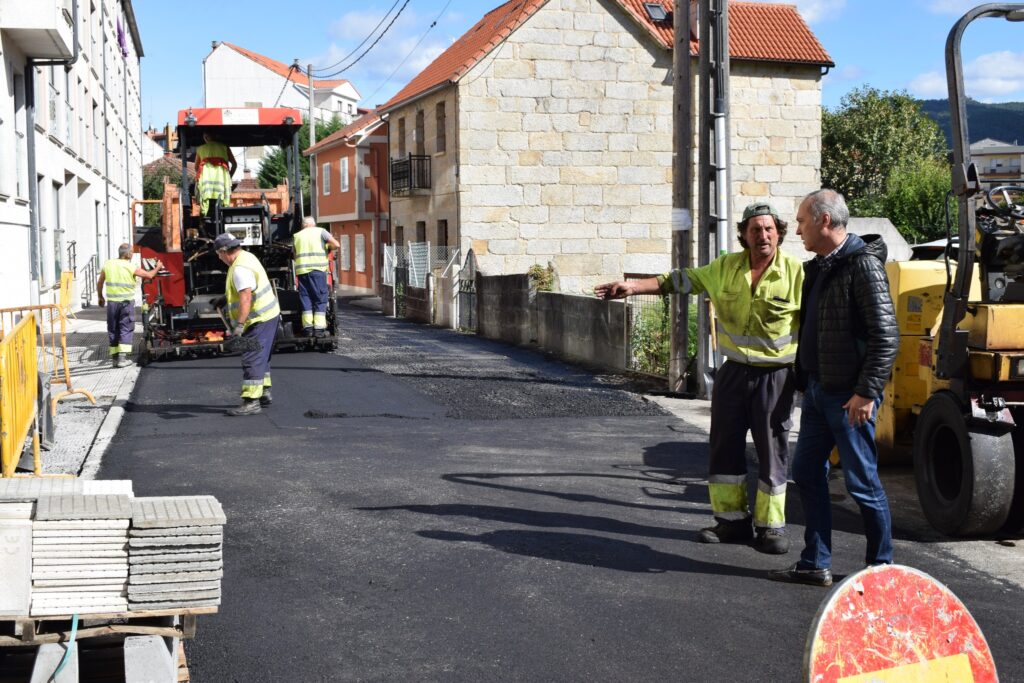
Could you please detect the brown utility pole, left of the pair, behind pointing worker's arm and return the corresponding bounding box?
[669,0,693,391]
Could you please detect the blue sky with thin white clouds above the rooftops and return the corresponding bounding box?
[134,0,1024,127]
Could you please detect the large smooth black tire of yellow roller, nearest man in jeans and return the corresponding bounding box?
[913,391,1016,536]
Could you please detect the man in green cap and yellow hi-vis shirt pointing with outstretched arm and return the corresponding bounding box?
[594,203,804,554]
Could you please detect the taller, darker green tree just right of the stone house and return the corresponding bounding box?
[821,86,946,216]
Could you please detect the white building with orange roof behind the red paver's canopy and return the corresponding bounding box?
[201,41,360,178]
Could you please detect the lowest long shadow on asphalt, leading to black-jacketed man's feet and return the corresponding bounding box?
[417,529,768,581]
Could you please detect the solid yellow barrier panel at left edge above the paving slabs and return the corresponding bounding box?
[0,312,42,477]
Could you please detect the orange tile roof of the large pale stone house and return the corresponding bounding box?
[378,0,835,112]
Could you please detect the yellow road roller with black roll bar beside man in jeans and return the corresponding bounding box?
[877,3,1024,536]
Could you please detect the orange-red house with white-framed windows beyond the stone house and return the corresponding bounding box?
[303,112,389,292]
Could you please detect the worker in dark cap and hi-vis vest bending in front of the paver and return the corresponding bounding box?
[213,232,281,416]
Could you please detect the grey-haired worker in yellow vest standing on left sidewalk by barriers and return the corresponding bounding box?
[96,243,164,368]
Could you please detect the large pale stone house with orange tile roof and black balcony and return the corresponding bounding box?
[379,0,833,292]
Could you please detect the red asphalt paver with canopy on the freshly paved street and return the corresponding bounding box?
[136,108,337,361]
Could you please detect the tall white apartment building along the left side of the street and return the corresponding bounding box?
[0,0,142,308]
